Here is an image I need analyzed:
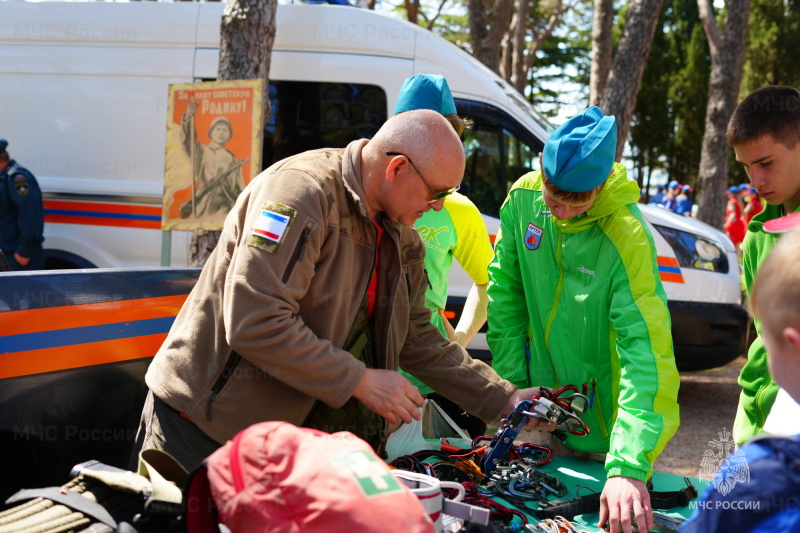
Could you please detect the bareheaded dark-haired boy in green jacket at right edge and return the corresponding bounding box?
[727,85,800,444]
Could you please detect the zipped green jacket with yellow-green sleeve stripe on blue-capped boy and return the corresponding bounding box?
[488,164,680,481]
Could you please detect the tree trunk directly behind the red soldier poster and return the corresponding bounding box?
[189,0,278,267]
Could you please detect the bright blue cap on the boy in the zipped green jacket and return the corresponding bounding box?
[542,106,617,192]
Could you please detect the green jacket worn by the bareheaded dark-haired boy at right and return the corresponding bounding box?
[733,204,800,445]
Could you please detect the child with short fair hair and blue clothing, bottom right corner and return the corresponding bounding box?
[681,224,800,533]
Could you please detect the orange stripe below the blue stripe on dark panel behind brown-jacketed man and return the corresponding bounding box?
[0,333,167,379]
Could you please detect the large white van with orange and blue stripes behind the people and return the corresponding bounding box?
[0,1,747,368]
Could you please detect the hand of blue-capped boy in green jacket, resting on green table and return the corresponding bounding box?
[597,476,654,533]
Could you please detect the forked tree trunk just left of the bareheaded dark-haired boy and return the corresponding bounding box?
[697,0,750,229]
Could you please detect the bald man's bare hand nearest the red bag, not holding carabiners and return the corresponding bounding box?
[353,368,425,424]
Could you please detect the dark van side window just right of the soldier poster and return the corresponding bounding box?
[262,81,386,168]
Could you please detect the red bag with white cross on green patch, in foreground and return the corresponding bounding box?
[184,422,435,533]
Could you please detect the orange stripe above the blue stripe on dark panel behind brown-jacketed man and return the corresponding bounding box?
[0,294,188,335]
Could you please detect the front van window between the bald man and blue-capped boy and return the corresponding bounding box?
[456,99,544,217]
